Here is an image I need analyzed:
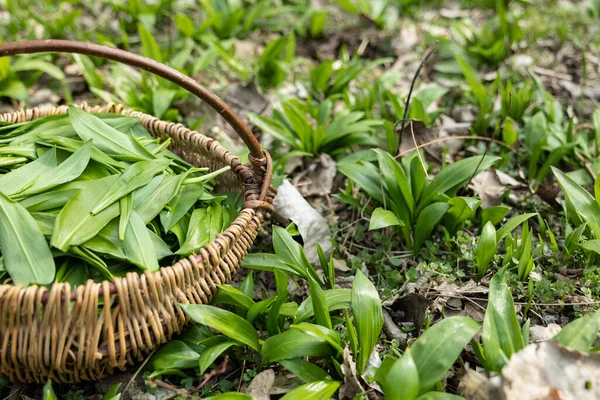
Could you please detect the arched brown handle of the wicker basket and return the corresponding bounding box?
[0,39,265,161]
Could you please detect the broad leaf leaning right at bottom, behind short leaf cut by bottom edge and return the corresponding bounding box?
[410,317,479,393]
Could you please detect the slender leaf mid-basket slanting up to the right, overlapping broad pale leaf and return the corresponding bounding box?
[91,160,170,215]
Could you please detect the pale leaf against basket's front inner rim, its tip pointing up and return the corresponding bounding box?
[123,211,160,271]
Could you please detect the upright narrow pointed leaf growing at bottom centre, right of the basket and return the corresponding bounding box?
[350,270,383,374]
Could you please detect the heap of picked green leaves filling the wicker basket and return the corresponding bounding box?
[0,107,239,285]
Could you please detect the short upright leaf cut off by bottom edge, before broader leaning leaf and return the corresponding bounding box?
[375,348,419,400]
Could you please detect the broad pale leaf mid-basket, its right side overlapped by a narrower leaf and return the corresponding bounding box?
[50,175,119,251]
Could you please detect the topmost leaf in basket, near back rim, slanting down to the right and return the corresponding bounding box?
[69,106,156,162]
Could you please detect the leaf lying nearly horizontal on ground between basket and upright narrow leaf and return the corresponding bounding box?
[262,329,335,363]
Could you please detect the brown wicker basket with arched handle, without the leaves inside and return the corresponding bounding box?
[0,40,276,382]
